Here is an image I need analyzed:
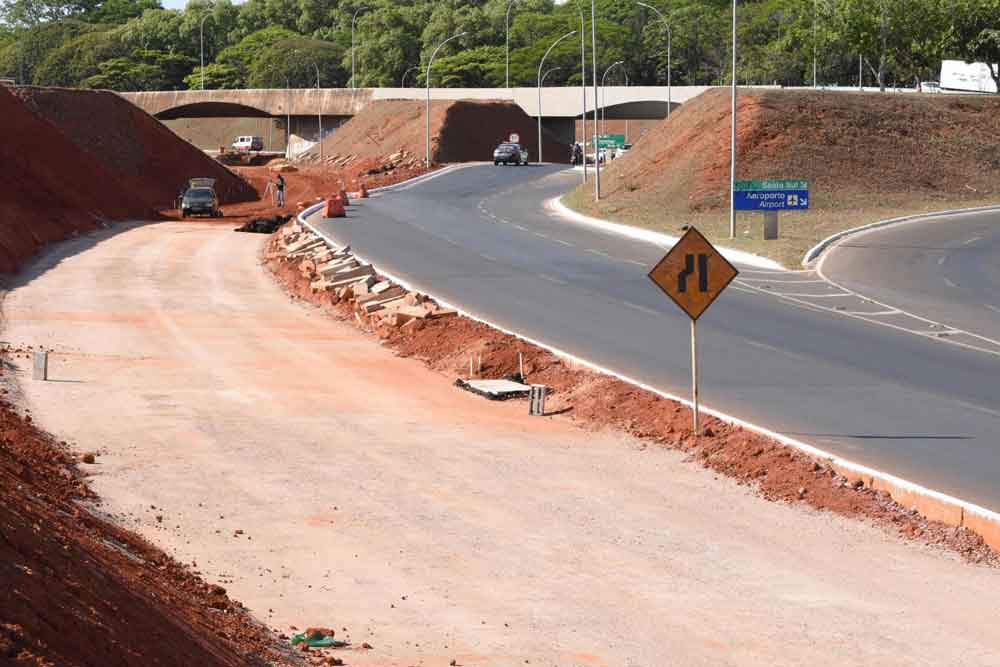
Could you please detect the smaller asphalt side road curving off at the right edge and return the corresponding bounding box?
[820,211,1000,340]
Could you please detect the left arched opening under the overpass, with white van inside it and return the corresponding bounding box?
[150,102,351,155]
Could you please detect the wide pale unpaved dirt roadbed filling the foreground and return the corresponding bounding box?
[4,223,1000,667]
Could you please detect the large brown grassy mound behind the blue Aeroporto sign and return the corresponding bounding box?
[588,89,1000,213]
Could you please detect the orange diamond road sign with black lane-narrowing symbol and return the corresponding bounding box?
[649,227,739,320]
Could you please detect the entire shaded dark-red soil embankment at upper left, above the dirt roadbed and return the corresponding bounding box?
[0,87,257,273]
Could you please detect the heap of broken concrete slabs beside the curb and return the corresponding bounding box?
[267,220,458,338]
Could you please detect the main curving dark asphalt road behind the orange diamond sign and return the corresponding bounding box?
[313,165,1000,509]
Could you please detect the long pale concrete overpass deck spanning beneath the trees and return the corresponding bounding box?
[122,86,708,120]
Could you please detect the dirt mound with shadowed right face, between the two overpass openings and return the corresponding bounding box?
[299,100,569,167]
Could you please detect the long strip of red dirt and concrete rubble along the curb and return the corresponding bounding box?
[264,222,1000,565]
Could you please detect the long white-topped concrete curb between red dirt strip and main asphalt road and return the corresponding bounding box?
[297,203,1000,551]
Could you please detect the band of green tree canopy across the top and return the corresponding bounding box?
[0,0,1000,90]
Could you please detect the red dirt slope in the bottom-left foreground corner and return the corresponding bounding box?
[0,349,300,667]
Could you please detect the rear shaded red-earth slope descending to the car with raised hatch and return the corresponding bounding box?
[13,87,256,210]
